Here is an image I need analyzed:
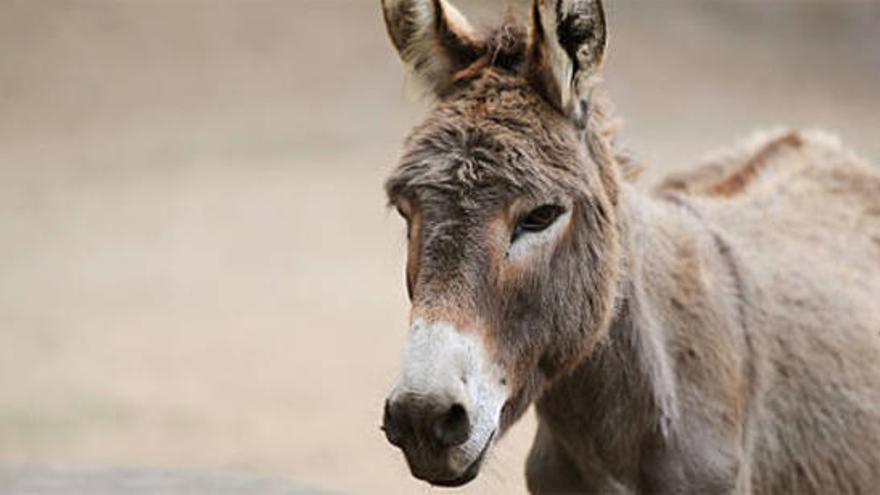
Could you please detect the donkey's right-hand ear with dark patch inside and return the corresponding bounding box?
[529,0,608,125]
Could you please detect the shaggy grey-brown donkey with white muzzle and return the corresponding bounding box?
[382,0,880,494]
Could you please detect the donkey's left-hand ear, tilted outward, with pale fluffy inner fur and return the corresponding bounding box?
[382,0,483,94]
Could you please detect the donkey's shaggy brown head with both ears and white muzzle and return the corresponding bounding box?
[383,0,620,486]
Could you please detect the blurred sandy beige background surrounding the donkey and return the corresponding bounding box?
[0,0,880,494]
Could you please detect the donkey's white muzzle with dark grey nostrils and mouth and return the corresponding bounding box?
[382,318,507,486]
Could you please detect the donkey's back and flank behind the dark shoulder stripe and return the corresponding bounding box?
[659,132,880,493]
